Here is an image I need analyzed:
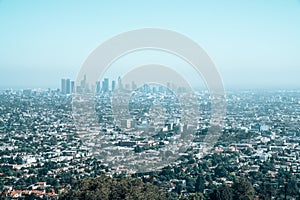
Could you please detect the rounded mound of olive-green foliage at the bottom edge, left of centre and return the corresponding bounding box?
[60,176,166,200]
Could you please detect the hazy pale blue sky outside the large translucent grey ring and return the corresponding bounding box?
[0,0,300,89]
